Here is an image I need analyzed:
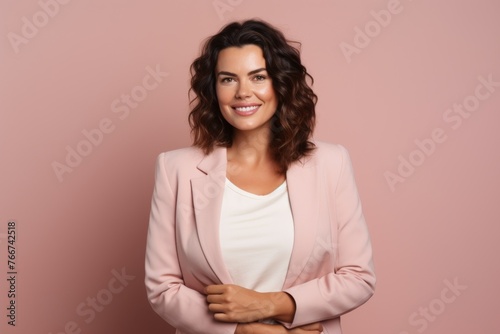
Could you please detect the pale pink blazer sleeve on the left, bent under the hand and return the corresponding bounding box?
[145,153,236,334]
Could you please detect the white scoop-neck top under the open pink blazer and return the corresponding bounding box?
[220,179,294,292]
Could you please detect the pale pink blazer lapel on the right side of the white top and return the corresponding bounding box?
[283,157,320,289]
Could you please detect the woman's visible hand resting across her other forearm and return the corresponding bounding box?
[205,284,275,323]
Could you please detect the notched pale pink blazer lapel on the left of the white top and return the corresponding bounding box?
[191,148,232,284]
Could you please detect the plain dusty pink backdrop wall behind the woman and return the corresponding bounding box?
[0,0,500,334]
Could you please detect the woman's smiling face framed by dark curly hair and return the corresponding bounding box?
[215,44,278,136]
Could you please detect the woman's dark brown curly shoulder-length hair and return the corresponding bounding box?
[189,20,317,173]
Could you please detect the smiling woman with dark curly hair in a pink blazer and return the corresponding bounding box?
[146,20,375,334]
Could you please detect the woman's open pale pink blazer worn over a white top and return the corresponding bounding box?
[145,142,375,334]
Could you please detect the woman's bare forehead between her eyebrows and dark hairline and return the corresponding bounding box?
[217,44,266,72]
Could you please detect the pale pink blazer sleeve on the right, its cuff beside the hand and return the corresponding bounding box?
[285,145,375,327]
